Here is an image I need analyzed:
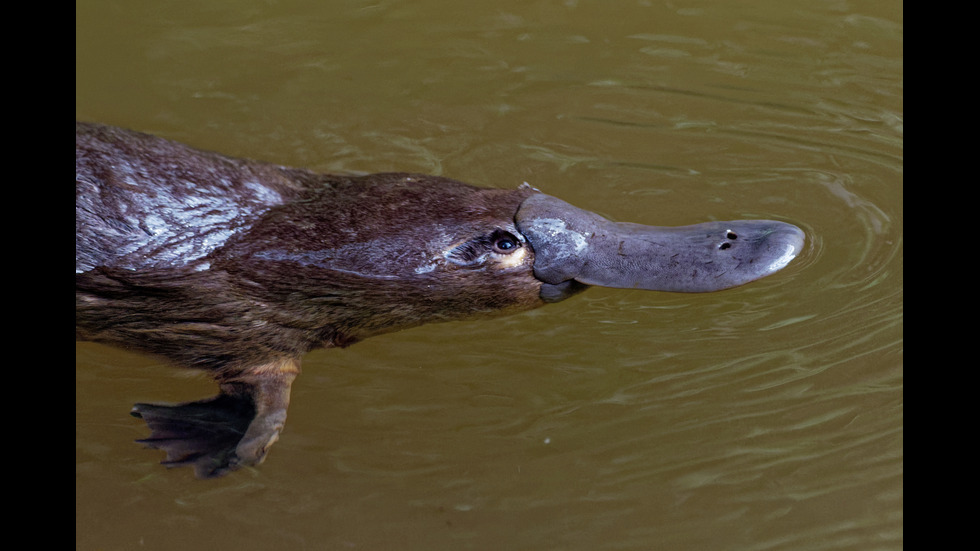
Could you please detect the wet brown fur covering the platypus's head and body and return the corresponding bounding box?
[75,123,543,376]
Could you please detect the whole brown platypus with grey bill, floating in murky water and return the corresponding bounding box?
[75,122,804,477]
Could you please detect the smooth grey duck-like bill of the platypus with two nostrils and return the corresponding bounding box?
[515,193,804,293]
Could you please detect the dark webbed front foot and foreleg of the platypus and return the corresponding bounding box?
[130,362,296,478]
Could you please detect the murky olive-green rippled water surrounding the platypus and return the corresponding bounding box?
[76,0,904,550]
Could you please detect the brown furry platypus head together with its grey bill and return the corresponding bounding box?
[218,173,803,346]
